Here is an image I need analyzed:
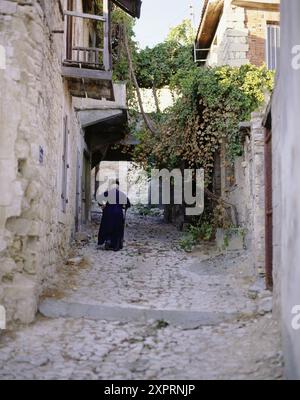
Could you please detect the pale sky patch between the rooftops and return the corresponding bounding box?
[135,0,203,48]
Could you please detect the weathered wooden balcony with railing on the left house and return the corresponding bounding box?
[62,0,114,101]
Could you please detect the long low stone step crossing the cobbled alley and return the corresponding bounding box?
[39,299,240,329]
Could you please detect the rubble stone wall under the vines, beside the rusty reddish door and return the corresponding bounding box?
[221,113,265,273]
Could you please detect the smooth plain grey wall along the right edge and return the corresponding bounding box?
[272,0,300,379]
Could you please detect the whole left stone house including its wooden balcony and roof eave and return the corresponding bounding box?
[0,0,141,322]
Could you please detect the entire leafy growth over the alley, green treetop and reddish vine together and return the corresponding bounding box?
[110,18,274,239]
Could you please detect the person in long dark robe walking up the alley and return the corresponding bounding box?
[98,181,131,251]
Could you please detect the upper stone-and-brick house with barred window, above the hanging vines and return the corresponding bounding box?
[195,0,280,69]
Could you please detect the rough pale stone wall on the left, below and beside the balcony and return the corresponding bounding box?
[0,0,83,322]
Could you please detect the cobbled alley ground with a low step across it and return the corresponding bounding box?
[0,210,282,380]
